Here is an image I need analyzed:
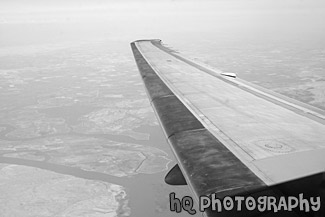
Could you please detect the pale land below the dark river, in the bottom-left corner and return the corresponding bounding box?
[0,164,130,217]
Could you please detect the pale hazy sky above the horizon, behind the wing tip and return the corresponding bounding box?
[0,0,325,46]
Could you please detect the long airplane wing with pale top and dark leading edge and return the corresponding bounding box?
[131,40,325,216]
